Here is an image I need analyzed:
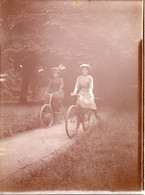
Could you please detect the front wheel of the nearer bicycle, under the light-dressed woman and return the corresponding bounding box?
[65,105,78,139]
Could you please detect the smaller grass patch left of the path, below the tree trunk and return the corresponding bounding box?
[0,104,41,137]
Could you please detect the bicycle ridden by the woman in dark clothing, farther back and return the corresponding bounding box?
[40,92,64,128]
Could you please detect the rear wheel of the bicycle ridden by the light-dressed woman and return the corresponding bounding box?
[82,110,92,131]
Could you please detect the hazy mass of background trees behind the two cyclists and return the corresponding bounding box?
[1,0,142,106]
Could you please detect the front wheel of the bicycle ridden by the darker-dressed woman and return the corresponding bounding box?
[40,104,54,128]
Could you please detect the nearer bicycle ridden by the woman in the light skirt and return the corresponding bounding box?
[65,94,101,139]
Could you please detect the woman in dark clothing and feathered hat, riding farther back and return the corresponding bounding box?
[46,65,65,111]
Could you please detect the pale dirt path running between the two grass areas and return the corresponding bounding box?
[0,124,81,180]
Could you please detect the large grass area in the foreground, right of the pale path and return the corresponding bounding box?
[1,108,140,191]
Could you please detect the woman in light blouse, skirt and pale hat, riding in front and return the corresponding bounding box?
[72,64,98,118]
